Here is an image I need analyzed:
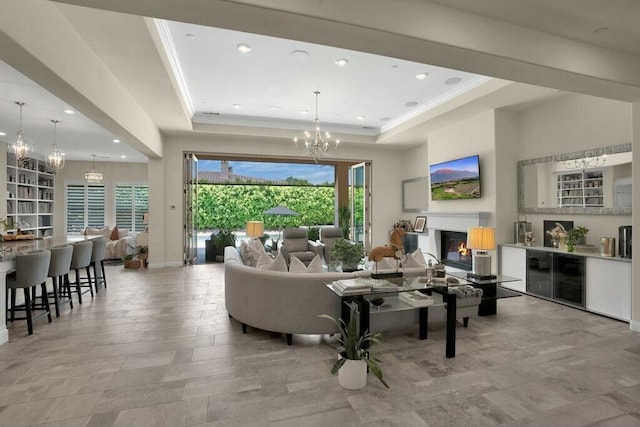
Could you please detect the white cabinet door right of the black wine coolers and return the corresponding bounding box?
[586,258,631,321]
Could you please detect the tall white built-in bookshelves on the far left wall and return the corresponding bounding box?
[5,153,54,237]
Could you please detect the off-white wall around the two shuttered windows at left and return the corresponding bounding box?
[53,161,148,236]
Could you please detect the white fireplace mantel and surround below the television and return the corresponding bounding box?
[421,212,491,262]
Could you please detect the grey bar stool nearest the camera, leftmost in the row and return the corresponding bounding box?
[7,250,51,335]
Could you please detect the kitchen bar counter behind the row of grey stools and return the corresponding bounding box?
[0,236,100,345]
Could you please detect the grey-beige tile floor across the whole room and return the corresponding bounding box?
[0,264,640,427]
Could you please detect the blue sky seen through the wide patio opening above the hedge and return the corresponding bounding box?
[198,160,334,184]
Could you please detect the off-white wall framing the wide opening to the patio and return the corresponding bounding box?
[149,135,403,267]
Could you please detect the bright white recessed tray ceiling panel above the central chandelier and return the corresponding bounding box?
[162,21,487,135]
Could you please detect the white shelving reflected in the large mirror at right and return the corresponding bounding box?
[557,169,604,207]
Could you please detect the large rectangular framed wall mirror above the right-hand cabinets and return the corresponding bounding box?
[518,144,632,215]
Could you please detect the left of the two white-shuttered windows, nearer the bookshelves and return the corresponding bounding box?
[66,184,105,234]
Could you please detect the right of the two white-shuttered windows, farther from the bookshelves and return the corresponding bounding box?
[116,184,149,231]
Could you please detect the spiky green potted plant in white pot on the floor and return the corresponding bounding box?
[318,308,389,390]
